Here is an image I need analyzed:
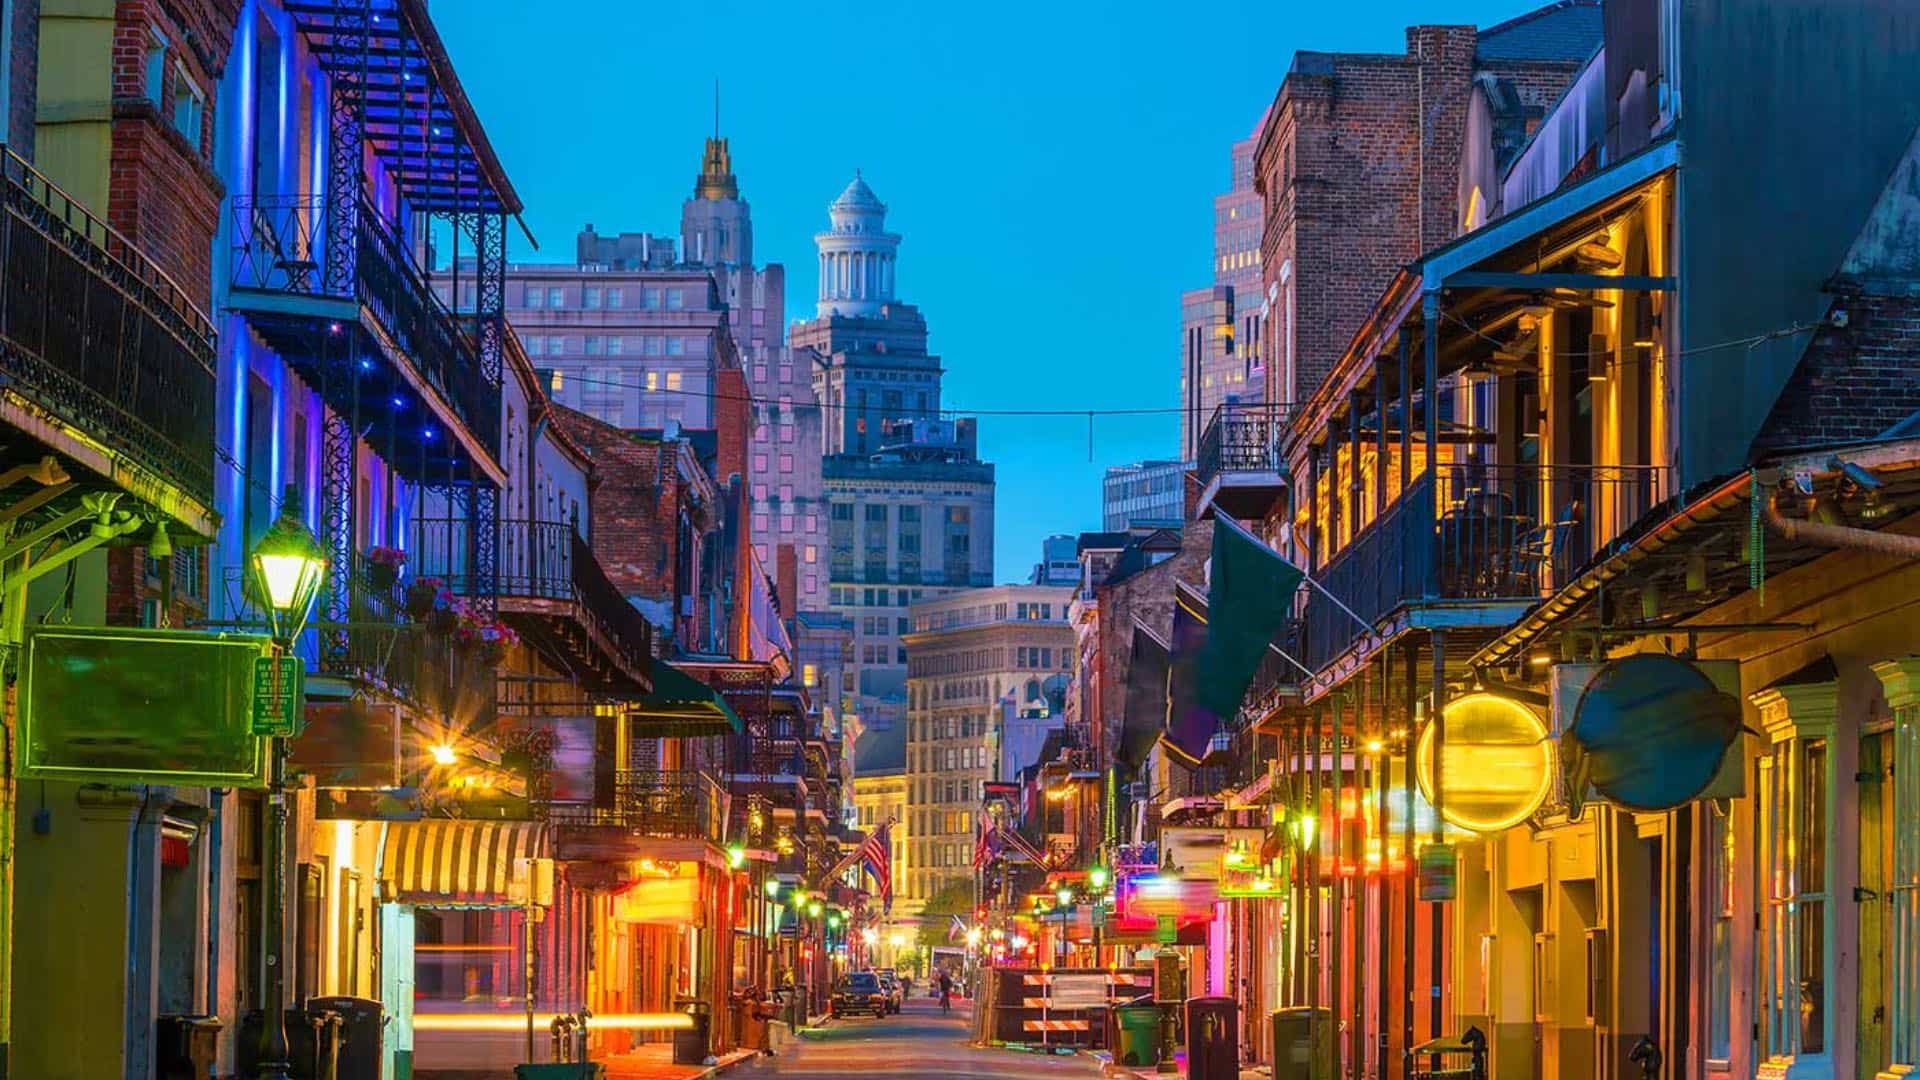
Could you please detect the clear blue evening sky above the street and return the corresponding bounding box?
[432,0,1546,580]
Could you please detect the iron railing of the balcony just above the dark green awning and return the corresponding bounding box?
[407,519,653,671]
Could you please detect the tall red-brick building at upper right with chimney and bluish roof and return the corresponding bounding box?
[1254,0,1601,402]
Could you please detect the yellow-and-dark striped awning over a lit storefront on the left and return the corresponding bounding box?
[380,819,551,907]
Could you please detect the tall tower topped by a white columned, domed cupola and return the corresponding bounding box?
[789,175,993,728]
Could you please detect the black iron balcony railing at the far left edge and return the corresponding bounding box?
[0,146,215,505]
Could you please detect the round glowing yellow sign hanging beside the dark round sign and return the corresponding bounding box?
[1413,694,1553,832]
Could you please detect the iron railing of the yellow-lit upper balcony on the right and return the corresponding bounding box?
[1306,463,1667,669]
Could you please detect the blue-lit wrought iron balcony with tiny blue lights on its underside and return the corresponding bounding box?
[228,196,501,466]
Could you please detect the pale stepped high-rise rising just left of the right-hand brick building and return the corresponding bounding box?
[1181,113,1267,461]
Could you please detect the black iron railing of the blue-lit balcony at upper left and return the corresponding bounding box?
[230,194,499,452]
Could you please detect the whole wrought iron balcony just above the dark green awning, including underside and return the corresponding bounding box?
[409,519,653,694]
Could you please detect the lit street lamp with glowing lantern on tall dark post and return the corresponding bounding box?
[248,486,326,1080]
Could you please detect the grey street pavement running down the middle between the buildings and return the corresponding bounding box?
[728,997,1098,1080]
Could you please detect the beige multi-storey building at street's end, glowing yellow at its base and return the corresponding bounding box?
[895,584,1073,905]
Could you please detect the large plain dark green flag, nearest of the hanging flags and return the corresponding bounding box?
[1196,509,1306,717]
